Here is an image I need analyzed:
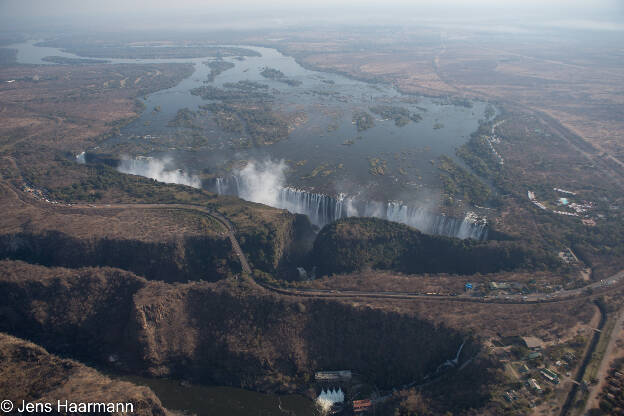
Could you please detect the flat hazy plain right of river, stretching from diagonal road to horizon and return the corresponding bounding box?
[252,29,624,174]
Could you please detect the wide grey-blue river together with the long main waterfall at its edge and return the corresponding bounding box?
[9,41,495,238]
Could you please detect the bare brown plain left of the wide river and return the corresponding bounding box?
[0,64,191,152]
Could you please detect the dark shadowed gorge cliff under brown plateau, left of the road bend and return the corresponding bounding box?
[0,231,240,282]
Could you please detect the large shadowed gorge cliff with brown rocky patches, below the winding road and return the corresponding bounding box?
[0,261,471,391]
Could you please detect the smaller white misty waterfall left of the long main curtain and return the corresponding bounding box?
[117,156,201,188]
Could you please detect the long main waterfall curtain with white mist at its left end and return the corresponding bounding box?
[214,176,487,240]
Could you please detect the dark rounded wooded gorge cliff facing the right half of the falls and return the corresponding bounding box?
[313,218,558,275]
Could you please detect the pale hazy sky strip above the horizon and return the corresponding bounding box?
[0,0,624,30]
